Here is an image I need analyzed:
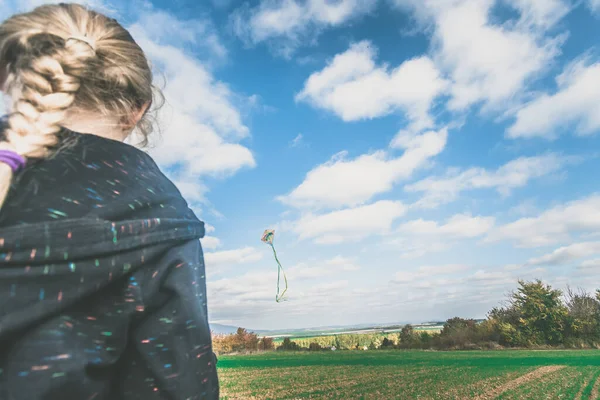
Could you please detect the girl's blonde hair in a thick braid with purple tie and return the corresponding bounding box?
[0,4,156,207]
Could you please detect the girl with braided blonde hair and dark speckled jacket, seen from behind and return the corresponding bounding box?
[0,4,218,400]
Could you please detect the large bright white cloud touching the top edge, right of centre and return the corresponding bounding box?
[394,0,563,110]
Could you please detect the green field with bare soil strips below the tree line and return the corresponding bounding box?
[218,350,600,400]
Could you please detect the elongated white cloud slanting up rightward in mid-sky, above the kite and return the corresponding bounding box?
[279,129,448,208]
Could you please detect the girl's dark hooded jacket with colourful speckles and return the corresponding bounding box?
[0,132,219,400]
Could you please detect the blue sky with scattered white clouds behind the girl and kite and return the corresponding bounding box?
[0,0,600,329]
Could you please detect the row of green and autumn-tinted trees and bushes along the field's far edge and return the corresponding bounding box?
[213,280,600,354]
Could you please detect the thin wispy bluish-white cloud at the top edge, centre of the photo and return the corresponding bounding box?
[231,0,377,57]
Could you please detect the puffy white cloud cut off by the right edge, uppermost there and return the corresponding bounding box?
[507,60,600,139]
